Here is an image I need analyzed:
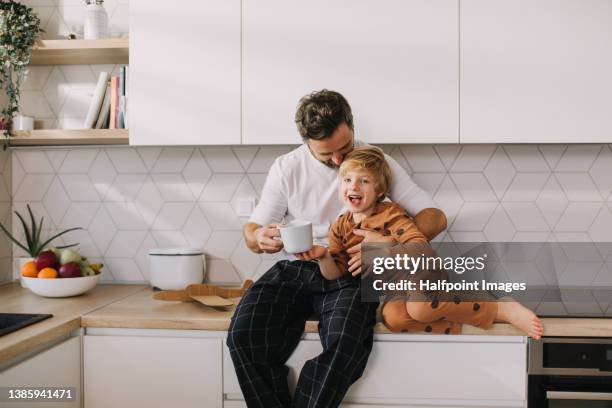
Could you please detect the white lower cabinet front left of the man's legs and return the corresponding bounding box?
[83,336,223,408]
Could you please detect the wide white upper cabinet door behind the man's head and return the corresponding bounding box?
[242,0,459,144]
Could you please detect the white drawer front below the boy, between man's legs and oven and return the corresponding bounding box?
[348,342,527,401]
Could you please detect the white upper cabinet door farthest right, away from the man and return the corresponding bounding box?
[460,0,612,143]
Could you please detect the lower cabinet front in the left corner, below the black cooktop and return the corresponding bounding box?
[0,337,81,408]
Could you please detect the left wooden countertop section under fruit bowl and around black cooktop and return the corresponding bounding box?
[0,283,146,364]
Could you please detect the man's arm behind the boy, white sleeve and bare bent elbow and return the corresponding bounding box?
[385,155,446,241]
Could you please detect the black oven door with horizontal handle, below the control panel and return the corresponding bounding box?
[527,375,612,408]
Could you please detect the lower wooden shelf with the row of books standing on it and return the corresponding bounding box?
[10,129,128,146]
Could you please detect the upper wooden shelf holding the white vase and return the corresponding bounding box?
[30,38,129,65]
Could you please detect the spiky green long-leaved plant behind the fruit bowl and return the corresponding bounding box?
[0,204,82,286]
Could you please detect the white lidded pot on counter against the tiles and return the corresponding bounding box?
[149,248,206,290]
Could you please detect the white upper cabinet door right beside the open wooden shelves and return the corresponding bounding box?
[128,0,240,145]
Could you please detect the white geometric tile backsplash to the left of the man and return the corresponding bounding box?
[8,146,291,283]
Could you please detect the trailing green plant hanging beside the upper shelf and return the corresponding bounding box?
[0,0,43,147]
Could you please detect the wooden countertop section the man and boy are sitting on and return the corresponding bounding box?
[81,289,612,337]
